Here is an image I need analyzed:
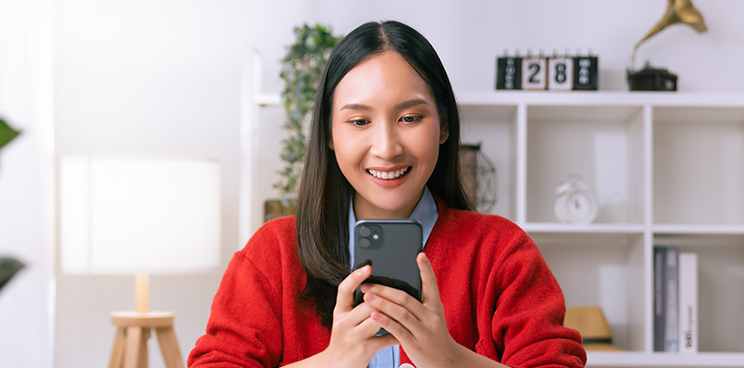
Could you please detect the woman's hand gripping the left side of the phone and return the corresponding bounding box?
[316,266,404,368]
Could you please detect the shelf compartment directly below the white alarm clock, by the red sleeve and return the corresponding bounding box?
[528,231,645,352]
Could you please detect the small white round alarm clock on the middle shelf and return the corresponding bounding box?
[553,175,599,224]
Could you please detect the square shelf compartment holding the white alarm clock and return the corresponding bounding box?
[526,106,644,224]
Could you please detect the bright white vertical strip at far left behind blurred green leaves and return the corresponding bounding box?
[0,0,54,368]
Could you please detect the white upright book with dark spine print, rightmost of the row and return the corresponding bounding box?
[678,253,698,354]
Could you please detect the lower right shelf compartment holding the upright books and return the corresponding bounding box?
[653,233,744,354]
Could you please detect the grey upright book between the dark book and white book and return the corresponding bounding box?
[664,247,679,353]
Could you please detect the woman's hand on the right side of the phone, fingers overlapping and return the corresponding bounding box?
[362,253,469,367]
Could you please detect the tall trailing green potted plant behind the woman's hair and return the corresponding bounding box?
[264,24,341,221]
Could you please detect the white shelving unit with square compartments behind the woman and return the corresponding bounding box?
[240,52,744,368]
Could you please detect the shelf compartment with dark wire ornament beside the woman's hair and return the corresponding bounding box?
[460,105,517,221]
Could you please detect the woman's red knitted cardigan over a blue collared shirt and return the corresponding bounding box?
[188,199,586,367]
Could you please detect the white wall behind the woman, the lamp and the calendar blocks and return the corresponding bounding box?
[33,0,744,368]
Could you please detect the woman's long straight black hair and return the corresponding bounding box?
[296,21,471,329]
